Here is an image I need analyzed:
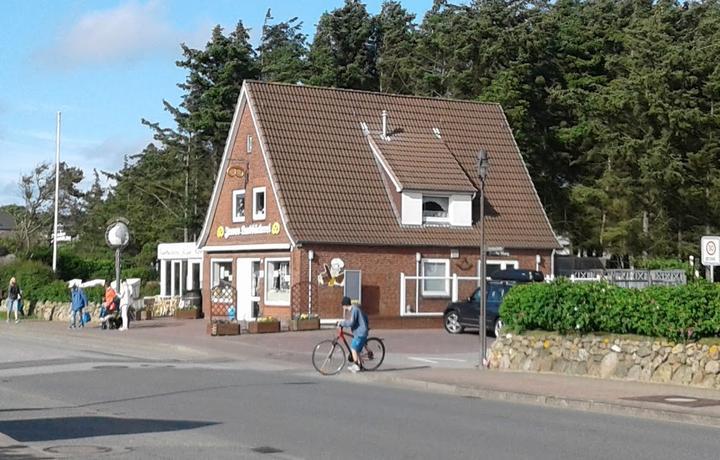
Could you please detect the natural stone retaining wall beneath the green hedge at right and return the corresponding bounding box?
[490,333,720,389]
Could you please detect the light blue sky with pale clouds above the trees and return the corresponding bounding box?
[0,0,432,206]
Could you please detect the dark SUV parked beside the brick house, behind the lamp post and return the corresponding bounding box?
[443,270,544,337]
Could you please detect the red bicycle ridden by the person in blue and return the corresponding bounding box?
[312,328,385,375]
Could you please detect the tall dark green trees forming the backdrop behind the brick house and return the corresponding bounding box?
[1,0,720,274]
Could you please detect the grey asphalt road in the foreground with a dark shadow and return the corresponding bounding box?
[0,324,720,460]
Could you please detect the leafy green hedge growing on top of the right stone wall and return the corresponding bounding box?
[500,280,720,340]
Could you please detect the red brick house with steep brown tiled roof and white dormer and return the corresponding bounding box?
[198,81,560,327]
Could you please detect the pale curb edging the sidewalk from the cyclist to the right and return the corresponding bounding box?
[348,374,720,428]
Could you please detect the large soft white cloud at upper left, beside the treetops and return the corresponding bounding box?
[39,0,188,68]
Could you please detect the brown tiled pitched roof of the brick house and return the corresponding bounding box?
[246,82,559,249]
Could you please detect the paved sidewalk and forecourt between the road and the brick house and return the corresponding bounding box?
[8,319,720,427]
